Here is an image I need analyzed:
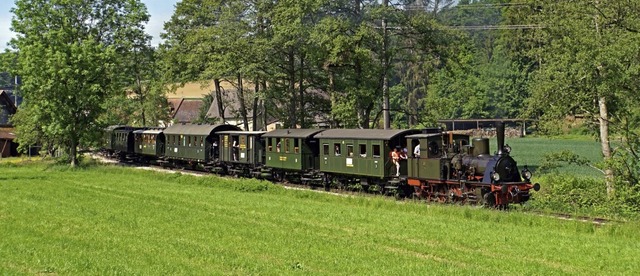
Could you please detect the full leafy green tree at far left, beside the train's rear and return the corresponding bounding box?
[11,0,149,166]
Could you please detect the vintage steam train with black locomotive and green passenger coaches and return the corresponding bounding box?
[102,122,540,208]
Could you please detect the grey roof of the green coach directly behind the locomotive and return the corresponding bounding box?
[314,129,420,140]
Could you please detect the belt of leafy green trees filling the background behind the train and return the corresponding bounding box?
[0,0,640,213]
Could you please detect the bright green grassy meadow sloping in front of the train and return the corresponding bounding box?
[0,164,640,275]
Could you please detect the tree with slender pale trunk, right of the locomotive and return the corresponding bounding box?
[530,0,640,196]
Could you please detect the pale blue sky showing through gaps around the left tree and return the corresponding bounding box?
[0,0,179,51]
